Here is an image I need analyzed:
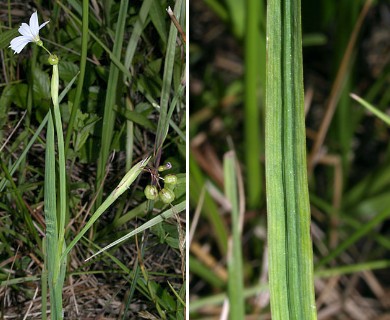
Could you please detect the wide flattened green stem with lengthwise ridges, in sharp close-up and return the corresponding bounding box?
[265,0,317,320]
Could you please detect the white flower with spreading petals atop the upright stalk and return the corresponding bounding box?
[9,11,49,53]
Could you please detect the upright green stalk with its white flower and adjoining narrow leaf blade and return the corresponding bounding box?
[9,12,67,319]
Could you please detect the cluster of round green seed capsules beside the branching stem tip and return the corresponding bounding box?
[144,162,177,204]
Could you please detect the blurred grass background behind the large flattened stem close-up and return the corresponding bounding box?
[189,0,390,319]
